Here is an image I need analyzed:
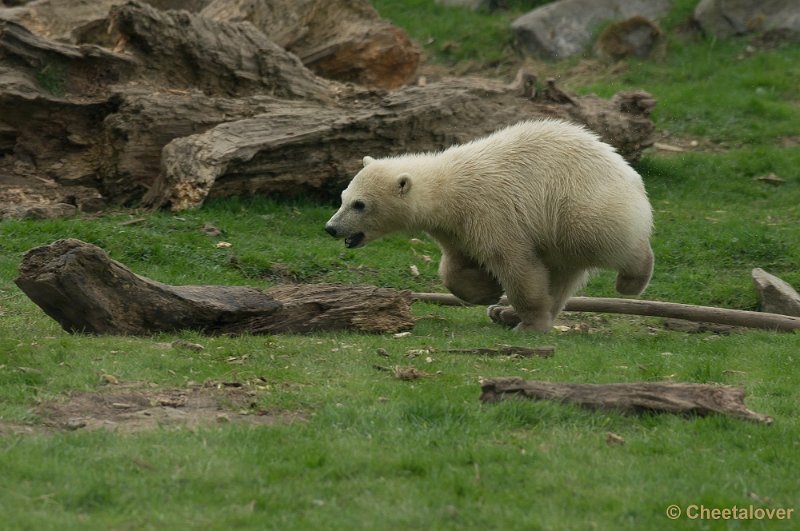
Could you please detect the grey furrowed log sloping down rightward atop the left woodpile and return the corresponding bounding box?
[104,2,330,100]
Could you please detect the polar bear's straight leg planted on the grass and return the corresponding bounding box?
[493,256,553,332]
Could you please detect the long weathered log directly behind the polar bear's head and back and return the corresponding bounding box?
[145,79,653,210]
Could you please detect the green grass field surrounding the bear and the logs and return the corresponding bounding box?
[0,0,800,530]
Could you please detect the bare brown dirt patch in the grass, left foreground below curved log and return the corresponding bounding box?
[0,381,306,434]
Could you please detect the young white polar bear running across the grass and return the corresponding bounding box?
[325,119,654,332]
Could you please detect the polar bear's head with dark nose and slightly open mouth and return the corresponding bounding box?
[325,157,411,249]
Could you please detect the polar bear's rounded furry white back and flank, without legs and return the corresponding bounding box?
[440,120,652,268]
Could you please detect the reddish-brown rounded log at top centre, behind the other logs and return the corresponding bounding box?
[200,0,420,88]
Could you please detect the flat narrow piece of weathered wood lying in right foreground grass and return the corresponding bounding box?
[480,378,772,424]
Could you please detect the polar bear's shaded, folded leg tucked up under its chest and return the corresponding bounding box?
[439,251,503,304]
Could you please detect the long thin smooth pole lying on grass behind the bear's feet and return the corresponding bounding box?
[411,293,800,332]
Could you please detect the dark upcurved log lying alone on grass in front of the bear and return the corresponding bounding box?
[15,239,414,335]
